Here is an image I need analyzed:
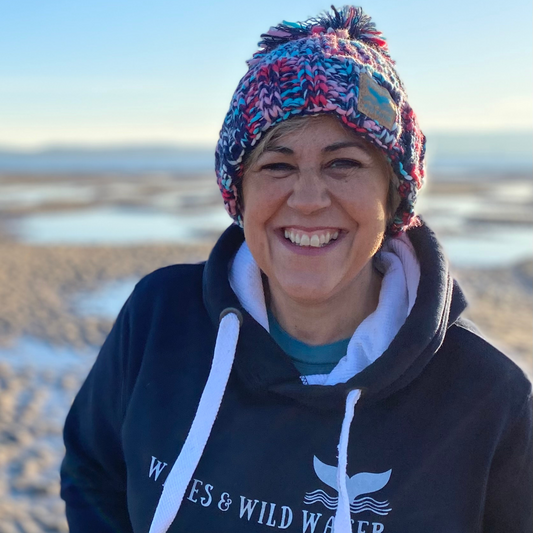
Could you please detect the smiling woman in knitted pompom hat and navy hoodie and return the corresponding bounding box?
[62,7,533,533]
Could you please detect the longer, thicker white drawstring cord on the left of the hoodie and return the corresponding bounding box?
[149,309,240,533]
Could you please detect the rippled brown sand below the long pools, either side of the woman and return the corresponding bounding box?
[0,241,533,533]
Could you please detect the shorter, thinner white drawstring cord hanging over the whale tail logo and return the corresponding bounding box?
[333,389,361,533]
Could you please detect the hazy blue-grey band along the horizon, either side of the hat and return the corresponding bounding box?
[0,130,533,179]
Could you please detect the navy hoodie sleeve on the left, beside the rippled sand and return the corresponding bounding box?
[61,297,137,533]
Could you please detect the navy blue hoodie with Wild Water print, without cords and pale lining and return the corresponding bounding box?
[61,226,533,533]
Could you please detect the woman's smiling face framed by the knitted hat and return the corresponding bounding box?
[243,116,389,303]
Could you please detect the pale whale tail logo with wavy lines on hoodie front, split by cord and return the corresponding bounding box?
[304,456,392,516]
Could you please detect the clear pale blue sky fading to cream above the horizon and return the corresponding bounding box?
[0,0,533,149]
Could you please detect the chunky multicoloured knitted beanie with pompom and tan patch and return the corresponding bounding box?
[216,6,425,234]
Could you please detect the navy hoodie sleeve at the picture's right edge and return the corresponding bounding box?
[483,384,533,533]
